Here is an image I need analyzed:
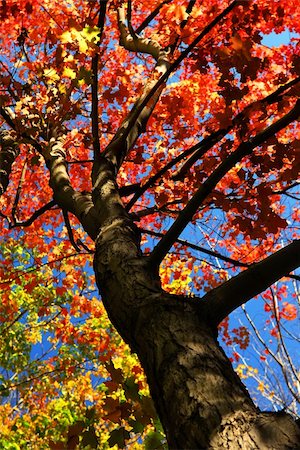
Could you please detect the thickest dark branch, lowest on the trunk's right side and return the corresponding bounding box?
[202,240,300,325]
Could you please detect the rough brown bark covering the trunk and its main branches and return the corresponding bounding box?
[0,0,300,450]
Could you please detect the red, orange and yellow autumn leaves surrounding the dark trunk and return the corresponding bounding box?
[0,0,300,450]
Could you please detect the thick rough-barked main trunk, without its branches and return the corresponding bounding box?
[94,217,300,450]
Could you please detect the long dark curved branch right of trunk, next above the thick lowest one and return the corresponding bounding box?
[150,100,300,265]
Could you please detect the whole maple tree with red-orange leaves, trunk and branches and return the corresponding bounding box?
[0,0,300,449]
